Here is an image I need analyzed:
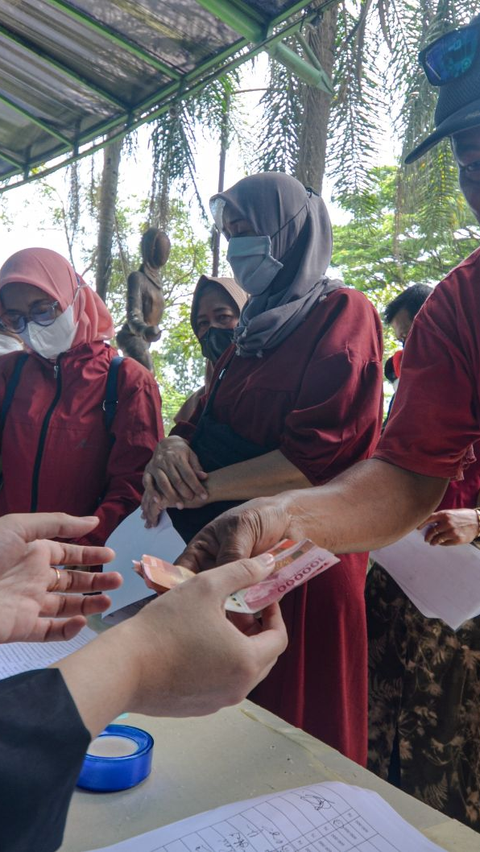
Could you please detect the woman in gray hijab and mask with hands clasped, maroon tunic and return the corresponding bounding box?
[142,172,382,763]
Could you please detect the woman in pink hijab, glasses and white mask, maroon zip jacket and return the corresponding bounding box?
[0,248,163,544]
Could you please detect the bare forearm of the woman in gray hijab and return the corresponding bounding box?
[206,450,311,503]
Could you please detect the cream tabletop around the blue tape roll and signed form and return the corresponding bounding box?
[61,701,480,852]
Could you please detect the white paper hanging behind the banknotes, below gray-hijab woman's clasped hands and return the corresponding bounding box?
[102,508,186,620]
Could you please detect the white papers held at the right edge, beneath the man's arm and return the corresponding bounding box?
[370,530,480,630]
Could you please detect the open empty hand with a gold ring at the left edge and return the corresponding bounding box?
[0,512,122,642]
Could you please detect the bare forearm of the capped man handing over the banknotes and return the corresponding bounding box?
[278,459,448,553]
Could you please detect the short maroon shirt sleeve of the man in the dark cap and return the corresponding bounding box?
[375,278,480,479]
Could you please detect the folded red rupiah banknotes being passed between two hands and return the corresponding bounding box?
[133,538,339,614]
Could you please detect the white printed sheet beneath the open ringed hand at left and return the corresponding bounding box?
[0,627,97,680]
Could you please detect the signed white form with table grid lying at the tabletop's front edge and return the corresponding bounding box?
[83,781,441,852]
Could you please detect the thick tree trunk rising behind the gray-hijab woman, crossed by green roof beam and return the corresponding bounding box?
[295,2,338,192]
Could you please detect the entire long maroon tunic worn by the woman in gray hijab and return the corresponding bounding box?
[174,288,383,764]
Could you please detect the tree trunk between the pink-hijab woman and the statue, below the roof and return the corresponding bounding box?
[95,139,123,301]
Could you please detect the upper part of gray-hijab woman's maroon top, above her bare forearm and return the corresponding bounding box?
[173,288,382,485]
